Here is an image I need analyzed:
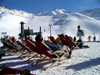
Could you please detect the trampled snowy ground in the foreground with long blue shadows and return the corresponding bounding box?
[0,42,100,75]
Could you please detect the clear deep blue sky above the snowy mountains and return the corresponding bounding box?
[0,0,100,13]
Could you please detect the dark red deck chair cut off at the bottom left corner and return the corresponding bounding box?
[0,64,35,75]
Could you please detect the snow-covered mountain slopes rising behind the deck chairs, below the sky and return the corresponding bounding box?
[0,6,100,40]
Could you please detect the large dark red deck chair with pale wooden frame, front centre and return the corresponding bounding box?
[34,42,69,70]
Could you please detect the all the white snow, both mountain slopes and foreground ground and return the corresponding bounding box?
[0,7,100,75]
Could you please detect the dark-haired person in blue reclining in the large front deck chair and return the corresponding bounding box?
[35,34,71,58]
